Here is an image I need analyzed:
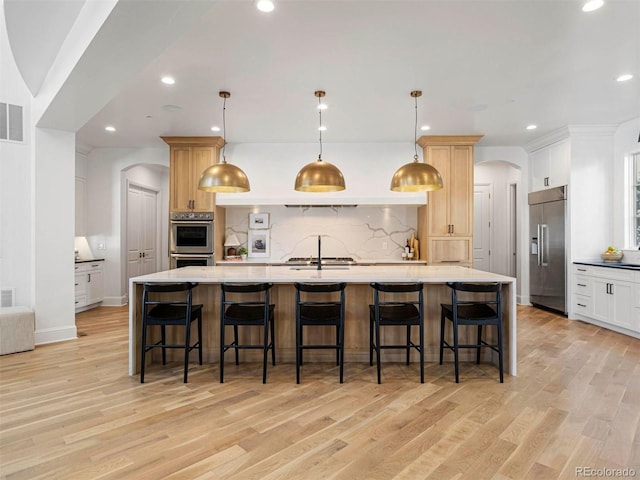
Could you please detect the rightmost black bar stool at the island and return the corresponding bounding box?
[440,282,504,383]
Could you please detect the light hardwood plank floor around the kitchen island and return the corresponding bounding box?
[0,307,640,480]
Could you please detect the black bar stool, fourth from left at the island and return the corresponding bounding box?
[369,283,424,383]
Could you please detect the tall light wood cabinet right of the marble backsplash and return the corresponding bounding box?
[418,135,482,267]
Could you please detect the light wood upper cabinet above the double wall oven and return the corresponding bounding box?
[162,137,223,212]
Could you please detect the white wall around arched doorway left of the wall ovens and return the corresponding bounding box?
[87,147,169,305]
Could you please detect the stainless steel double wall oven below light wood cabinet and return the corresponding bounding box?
[169,212,214,268]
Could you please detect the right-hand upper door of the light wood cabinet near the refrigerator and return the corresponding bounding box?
[449,146,473,237]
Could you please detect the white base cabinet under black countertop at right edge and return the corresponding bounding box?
[572,265,640,332]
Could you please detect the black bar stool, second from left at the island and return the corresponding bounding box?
[220,283,276,383]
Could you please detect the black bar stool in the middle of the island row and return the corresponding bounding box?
[295,282,347,383]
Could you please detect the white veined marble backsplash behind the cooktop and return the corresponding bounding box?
[225,206,418,261]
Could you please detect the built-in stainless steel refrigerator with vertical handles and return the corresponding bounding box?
[529,186,567,315]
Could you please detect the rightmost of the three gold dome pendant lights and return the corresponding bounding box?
[391,90,442,192]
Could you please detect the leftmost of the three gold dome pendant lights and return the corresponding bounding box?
[198,92,251,193]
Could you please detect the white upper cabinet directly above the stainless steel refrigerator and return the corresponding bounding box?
[529,140,571,192]
